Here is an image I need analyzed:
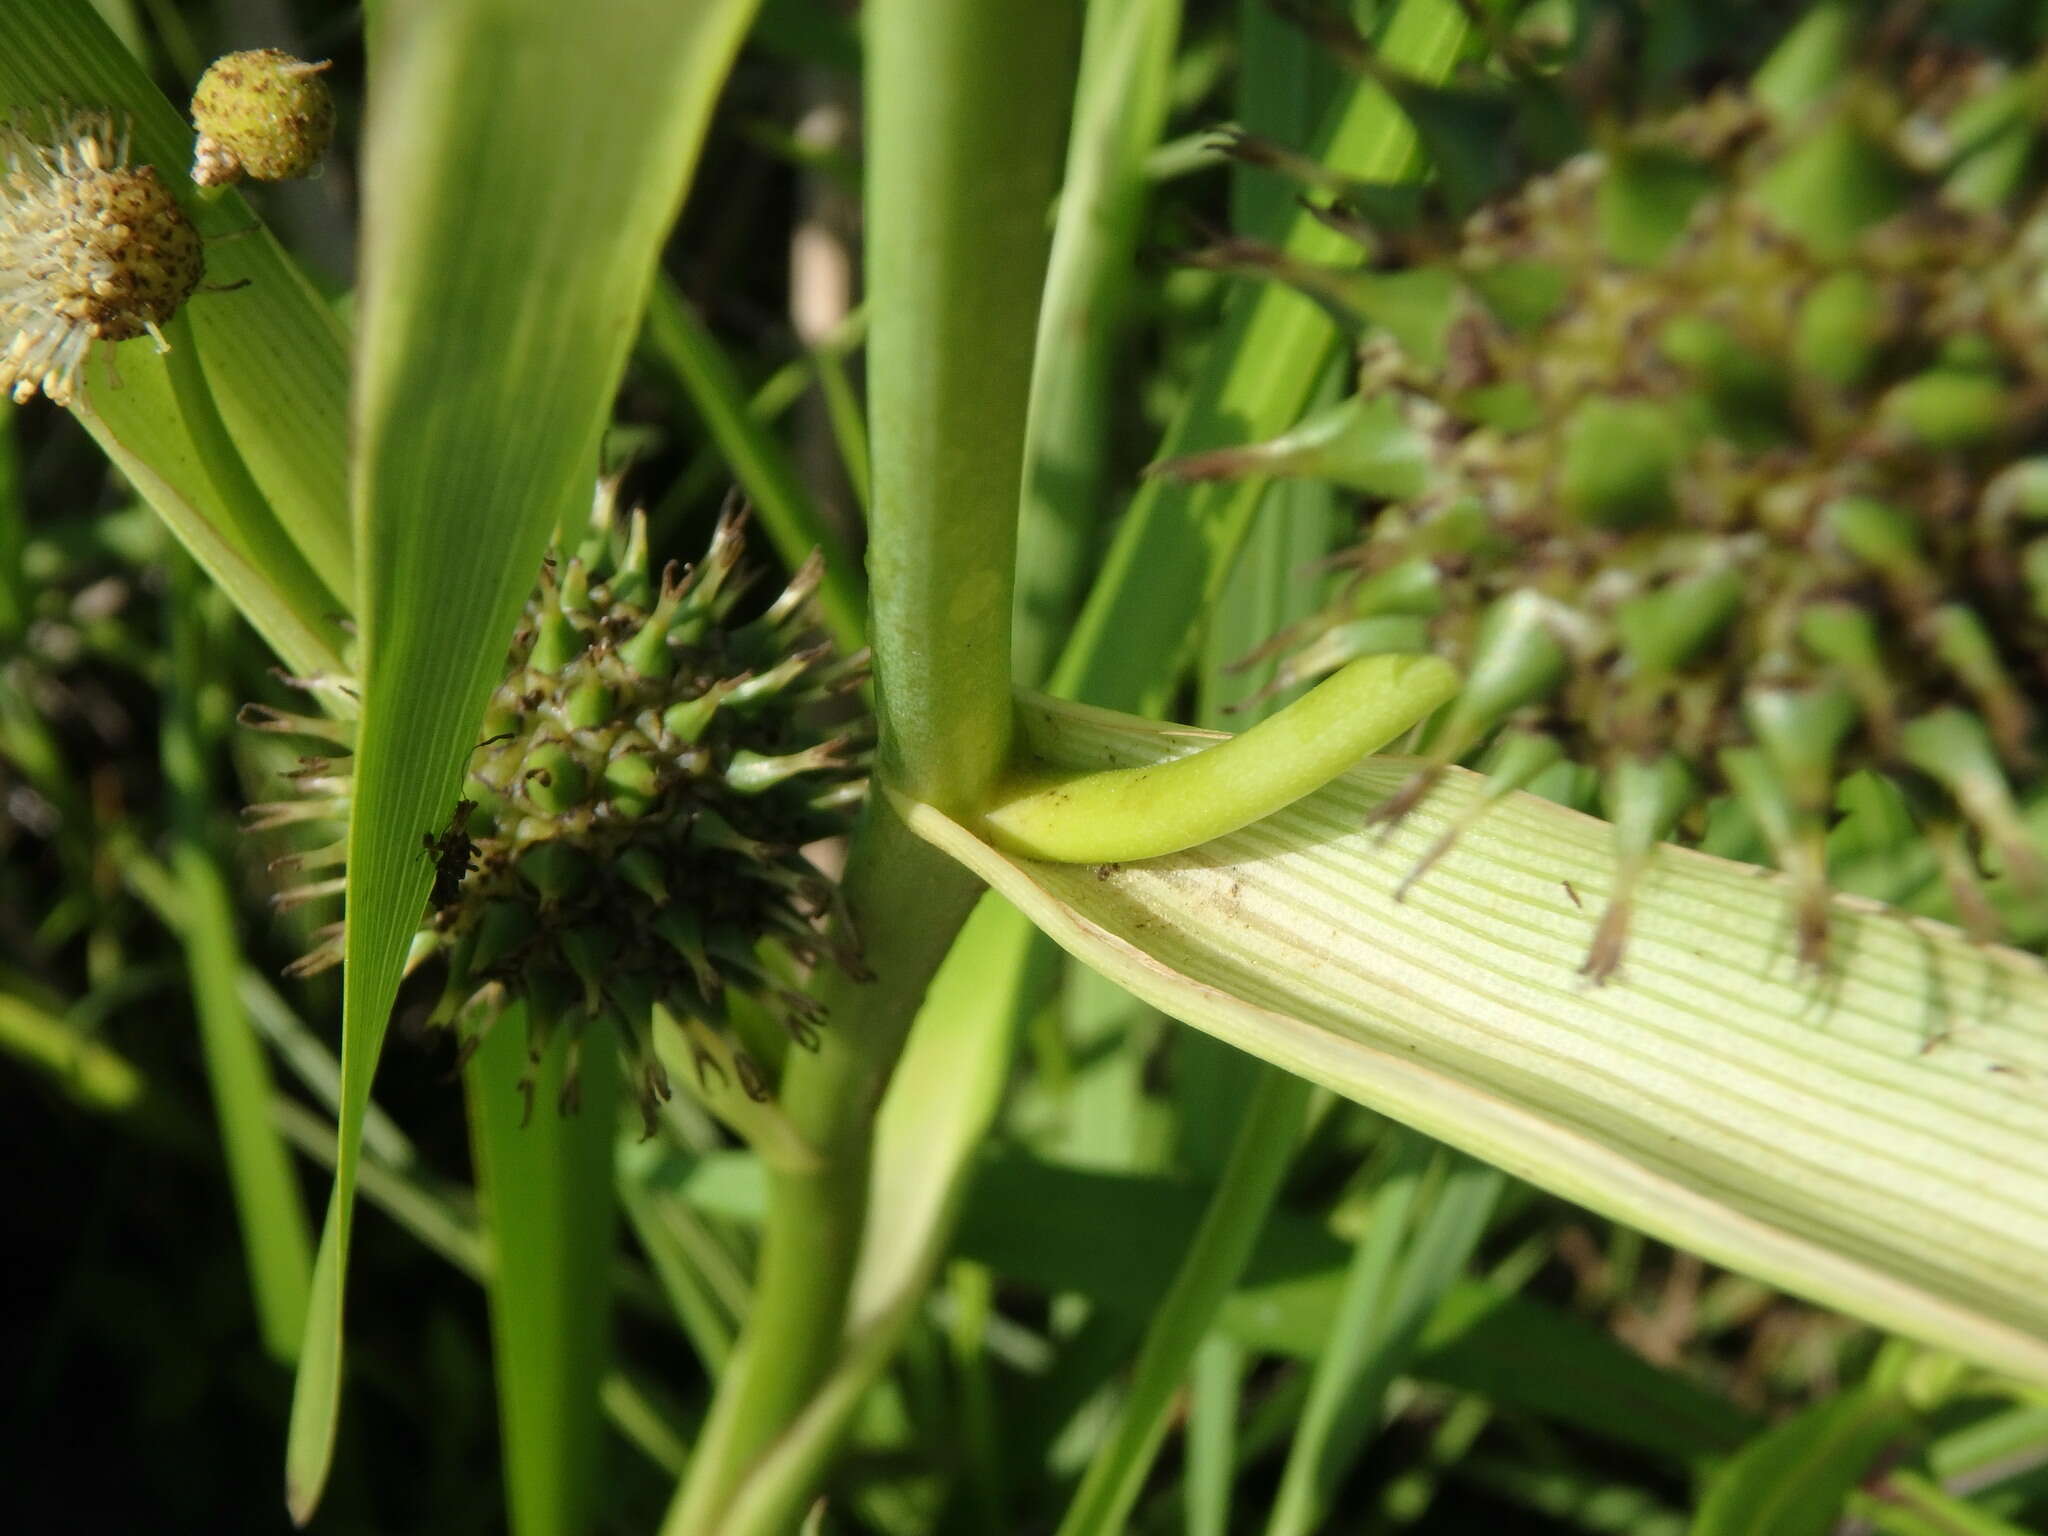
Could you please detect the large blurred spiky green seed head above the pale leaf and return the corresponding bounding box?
[1163,33,2048,975]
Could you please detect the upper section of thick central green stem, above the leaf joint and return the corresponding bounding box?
[868,0,1073,811]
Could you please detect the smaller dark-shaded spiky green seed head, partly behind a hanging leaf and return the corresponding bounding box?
[258,496,866,1124]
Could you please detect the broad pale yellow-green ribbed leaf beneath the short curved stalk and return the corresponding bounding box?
[905,700,2048,1380]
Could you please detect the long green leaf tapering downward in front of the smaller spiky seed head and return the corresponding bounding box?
[287,0,754,1520]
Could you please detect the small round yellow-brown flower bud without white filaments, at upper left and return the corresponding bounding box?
[193,47,334,186]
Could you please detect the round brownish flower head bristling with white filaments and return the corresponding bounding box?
[0,111,205,406]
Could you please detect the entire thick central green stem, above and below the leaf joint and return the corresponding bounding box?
[664,0,1073,1536]
